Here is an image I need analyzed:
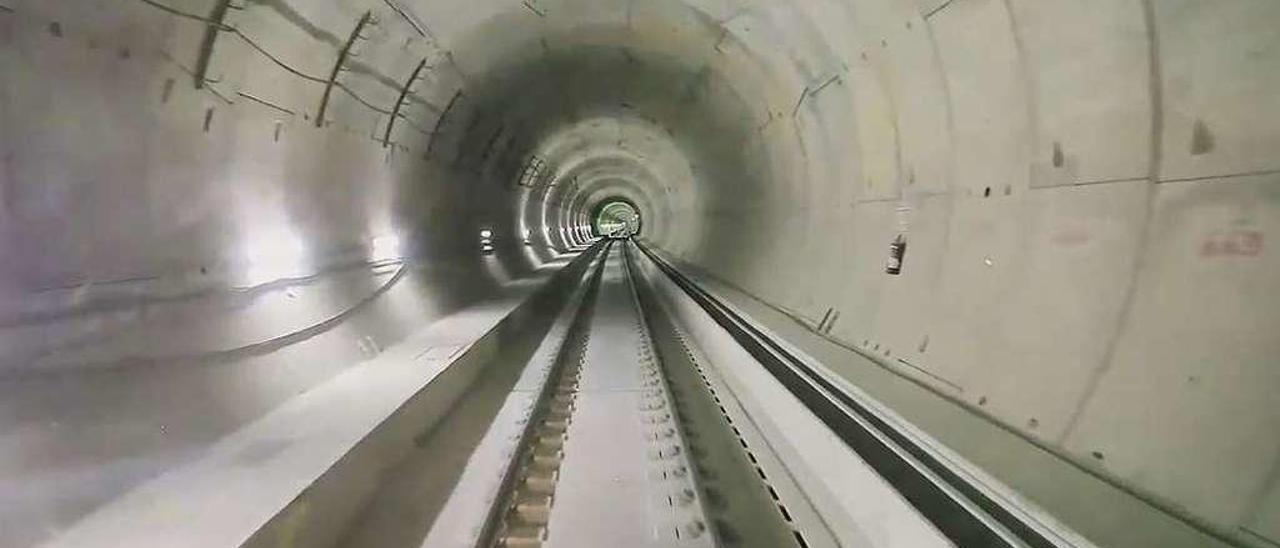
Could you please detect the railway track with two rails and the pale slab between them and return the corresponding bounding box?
[481,241,824,548]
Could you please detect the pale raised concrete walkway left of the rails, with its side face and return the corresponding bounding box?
[44,250,599,547]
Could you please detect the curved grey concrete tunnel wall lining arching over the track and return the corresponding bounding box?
[0,0,1280,544]
